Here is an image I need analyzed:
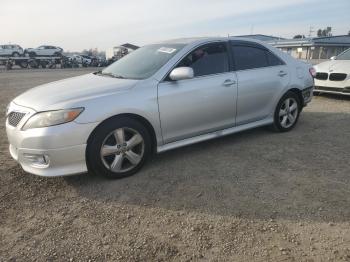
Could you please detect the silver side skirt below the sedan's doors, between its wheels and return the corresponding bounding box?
[157,117,273,153]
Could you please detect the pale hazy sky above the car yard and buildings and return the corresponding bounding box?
[0,0,350,51]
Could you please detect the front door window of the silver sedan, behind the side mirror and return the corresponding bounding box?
[176,43,229,77]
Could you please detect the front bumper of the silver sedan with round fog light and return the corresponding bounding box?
[6,102,98,177]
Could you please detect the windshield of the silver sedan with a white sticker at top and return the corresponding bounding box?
[101,44,185,79]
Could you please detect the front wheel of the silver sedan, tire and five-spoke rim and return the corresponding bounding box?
[86,117,151,179]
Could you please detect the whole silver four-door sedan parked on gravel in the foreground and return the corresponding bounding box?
[6,38,314,178]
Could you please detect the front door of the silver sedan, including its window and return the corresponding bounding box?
[158,42,237,143]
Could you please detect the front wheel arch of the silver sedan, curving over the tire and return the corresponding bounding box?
[87,113,157,153]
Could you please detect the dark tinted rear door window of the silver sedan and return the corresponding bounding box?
[232,45,283,70]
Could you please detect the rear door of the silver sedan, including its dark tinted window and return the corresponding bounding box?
[231,41,289,125]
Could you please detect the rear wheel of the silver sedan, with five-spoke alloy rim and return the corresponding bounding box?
[273,91,302,132]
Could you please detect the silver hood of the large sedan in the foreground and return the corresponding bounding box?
[13,74,139,111]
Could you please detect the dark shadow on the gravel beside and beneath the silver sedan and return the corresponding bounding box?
[60,109,350,221]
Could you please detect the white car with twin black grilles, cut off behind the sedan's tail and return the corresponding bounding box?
[314,48,350,95]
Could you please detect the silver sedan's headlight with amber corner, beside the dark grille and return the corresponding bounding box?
[22,108,84,130]
